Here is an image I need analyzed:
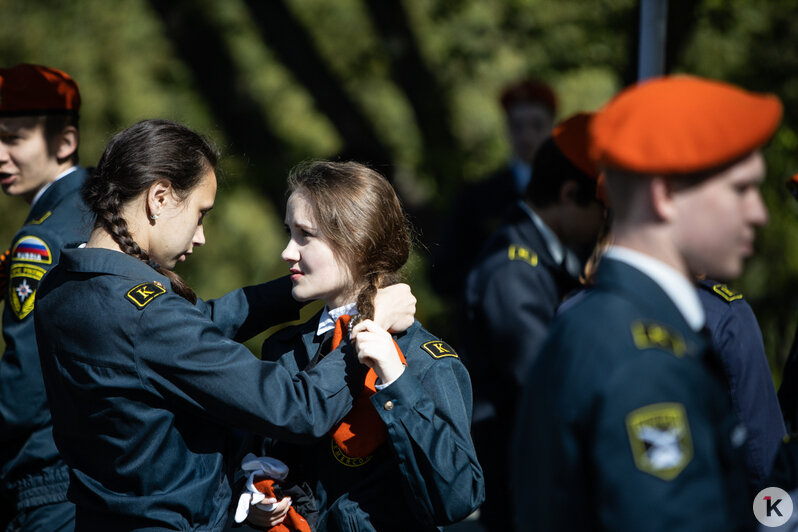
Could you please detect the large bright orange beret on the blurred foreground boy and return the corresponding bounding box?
[590,76,782,175]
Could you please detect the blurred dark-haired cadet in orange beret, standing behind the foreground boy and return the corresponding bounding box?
[462,113,605,532]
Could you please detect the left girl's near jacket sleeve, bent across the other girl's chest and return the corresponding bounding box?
[136,293,363,441]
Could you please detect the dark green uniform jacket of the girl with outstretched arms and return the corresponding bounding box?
[35,248,363,531]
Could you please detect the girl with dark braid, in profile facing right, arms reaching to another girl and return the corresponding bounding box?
[35,120,415,531]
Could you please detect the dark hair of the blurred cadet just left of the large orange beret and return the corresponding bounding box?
[526,138,596,207]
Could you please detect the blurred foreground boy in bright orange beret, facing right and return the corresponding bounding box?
[513,76,782,531]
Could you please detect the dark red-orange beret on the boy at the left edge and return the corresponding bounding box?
[0,64,80,116]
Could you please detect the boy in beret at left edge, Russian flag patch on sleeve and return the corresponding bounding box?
[0,64,93,531]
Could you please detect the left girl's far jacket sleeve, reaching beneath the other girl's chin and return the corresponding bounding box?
[197,276,304,342]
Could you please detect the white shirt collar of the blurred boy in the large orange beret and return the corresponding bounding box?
[605,246,706,331]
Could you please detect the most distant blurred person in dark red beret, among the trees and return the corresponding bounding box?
[430,79,557,308]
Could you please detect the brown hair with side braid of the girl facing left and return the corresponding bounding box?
[287,161,411,319]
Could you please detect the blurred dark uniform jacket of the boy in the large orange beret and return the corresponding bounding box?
[513,258,754,532]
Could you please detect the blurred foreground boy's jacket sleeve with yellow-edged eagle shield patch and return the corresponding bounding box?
[588,351,753,532]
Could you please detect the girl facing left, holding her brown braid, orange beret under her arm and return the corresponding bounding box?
[249,161,484,531]
